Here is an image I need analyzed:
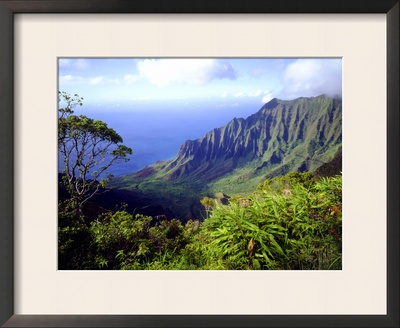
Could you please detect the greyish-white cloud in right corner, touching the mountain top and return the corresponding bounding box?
[282,59,342,98]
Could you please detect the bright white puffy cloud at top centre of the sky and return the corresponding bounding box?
[137,59,236,86]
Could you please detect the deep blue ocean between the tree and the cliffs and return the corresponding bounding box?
[59,101,262,176]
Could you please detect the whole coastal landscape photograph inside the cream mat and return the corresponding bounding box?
[57,57,342,270]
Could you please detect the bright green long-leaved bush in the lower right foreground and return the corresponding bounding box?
[203,175,342,270]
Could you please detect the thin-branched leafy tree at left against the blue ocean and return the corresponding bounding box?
[58,92,132,219]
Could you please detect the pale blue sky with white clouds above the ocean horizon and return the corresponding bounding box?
[59,58,342,112]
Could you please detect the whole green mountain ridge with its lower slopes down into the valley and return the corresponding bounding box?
[114,95,342,222]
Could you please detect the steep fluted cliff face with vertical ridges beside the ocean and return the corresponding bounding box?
[130,96,342,181]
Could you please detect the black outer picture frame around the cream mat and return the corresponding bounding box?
[0,0,400,327]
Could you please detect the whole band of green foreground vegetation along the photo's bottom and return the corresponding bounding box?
[59,172,342,270]
